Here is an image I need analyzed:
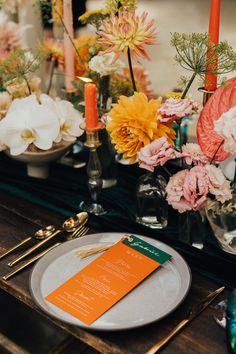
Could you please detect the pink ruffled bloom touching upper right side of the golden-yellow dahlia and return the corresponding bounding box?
[158,97,197,123]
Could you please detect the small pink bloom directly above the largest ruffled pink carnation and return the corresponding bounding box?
[181,143,209,165]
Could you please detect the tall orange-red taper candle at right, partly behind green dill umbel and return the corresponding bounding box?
[205,0,220,91]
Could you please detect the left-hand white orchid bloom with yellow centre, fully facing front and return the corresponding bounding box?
[0,95,60,155]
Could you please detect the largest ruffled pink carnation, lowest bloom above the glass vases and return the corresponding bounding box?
[166,166,209,213]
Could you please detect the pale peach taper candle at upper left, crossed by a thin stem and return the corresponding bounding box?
[63,0,75,92]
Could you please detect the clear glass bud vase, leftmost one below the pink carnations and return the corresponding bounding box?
[136,171,168,229]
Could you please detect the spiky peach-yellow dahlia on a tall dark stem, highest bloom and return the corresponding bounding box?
[98,10,157,61]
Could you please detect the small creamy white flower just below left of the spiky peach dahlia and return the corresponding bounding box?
[89,53,125,76]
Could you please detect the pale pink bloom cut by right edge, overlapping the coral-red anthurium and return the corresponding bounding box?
[215,106,236,154]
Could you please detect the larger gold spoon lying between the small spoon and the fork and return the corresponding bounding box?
[7,212,88,267]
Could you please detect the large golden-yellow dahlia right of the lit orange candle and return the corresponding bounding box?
[106,92,175,162]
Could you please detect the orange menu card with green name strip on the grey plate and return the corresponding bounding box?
[46,235,171,325]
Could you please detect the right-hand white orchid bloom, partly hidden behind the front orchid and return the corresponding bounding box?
[40,94,84,143]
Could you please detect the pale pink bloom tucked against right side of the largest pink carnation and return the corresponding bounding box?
[205,165,232,203]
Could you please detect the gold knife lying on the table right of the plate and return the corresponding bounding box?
[145,286,225,354]
